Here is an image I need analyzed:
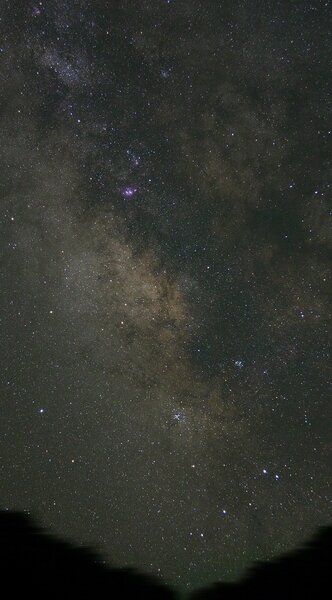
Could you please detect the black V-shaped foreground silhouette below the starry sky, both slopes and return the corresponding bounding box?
[0,511,332,600]
